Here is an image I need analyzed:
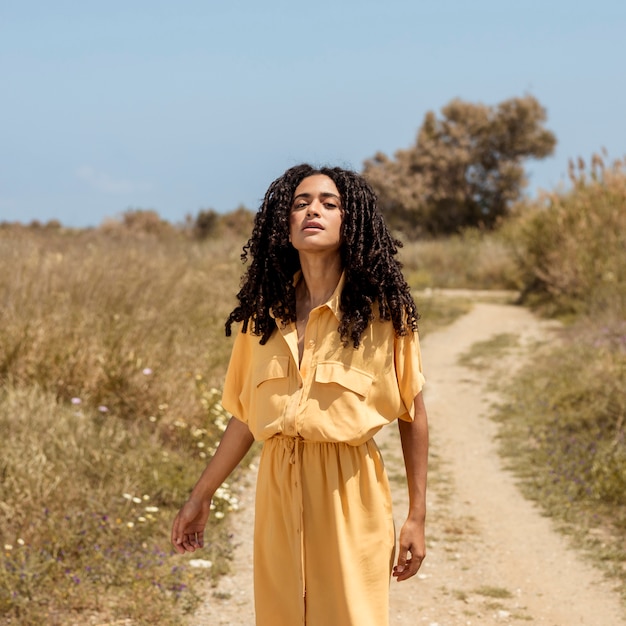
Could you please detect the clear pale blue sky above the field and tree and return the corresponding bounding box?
[0,0,626,226]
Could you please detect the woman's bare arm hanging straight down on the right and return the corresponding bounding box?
[393,392,428,580]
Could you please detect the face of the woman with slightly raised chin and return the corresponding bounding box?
[289,174,343,254]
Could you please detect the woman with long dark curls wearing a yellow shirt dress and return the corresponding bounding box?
[172,165,428,626]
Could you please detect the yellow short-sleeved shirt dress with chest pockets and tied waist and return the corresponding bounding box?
[222,278,424,626]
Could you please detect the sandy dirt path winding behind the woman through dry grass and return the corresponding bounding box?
[191,303,626,626]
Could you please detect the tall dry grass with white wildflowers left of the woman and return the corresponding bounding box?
[0,228,249,625]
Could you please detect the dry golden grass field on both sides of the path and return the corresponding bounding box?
[0,157,626,626]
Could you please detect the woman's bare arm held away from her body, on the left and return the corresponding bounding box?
[172,417,254,554]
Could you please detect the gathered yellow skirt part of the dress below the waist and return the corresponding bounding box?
[254,435,395,626]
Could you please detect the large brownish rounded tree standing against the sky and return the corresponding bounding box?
[363,96,556,236]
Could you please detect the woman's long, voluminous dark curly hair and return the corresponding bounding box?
[226,164,419,348]
